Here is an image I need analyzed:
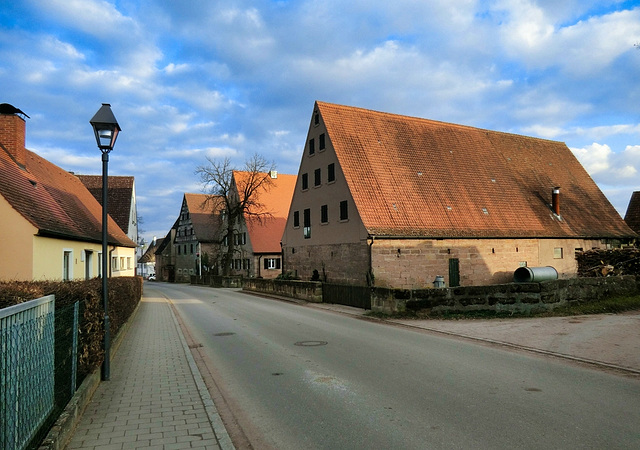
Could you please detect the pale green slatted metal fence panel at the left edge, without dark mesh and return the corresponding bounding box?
[0,295,55,450]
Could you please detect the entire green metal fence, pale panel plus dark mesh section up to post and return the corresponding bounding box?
[0,295,83,450]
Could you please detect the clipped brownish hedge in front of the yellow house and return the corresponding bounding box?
[0,277,142,375]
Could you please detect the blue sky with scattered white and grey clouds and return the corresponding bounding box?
[0,0,640,246]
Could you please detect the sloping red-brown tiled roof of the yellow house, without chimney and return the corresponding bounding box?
[0,147,136,247]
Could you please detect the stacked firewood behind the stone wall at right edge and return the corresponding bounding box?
[576,248,640,277]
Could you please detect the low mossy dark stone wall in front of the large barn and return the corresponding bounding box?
[371,276,640,313]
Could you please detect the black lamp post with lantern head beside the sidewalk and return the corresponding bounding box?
[89,103,121,381]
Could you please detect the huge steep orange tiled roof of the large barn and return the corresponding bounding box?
[316,102,635,238]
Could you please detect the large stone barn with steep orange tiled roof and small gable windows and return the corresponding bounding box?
[282,102,637,289]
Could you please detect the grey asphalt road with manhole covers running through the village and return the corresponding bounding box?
[145,283,640,449]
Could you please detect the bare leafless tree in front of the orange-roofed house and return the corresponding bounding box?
[196,154,274,276]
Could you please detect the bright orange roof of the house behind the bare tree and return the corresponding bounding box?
[233,171,297,253]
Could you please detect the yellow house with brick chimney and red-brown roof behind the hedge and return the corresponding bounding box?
[0,103,136,280]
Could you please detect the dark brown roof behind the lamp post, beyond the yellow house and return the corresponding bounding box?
[76,175,134,233]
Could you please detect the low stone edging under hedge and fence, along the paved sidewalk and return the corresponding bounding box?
[38,302,140,450]
